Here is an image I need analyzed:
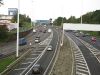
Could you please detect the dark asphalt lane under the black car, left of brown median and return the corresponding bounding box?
[23,27,58,75]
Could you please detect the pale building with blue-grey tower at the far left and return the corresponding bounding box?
[0,8,18,31]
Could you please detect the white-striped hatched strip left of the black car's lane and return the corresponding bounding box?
[7,27,52,75]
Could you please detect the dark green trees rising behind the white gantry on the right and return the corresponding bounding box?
[53,10,100,26]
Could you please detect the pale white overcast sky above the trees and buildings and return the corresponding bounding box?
[0,0,100,20]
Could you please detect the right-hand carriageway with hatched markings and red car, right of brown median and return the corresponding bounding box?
[65,31,100,75]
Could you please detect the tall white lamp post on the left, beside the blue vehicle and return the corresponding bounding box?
[16,0,20,57]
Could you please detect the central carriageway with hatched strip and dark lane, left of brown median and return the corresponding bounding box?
[7,26,58,75]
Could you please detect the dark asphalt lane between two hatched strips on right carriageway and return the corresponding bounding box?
[67,32,100,75]
